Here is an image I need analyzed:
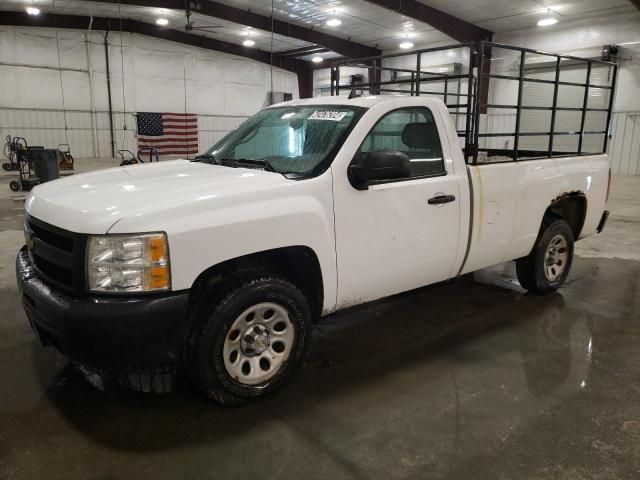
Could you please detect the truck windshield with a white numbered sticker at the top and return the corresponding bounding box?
[198,105,364,175]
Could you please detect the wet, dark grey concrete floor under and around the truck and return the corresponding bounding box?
[0,163,640,480]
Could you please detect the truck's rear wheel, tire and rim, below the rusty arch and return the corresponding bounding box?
[516,219,573,294]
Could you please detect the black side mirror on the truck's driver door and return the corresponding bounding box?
[349,150,411,190]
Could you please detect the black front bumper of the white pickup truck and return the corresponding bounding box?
[16,246,189,391]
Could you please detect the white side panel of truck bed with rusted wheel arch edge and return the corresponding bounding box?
[460,154,609,273]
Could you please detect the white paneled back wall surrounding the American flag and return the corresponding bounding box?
[0,27,298,157]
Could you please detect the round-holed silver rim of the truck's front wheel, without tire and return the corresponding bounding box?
[222,302,295,385]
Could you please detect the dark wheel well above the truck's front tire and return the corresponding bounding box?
[192,246,324,319]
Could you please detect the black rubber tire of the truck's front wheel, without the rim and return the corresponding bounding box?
[184,275,311,405]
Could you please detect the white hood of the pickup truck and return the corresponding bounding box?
[25,160,290,234]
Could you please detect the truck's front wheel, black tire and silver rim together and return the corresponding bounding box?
[185,276,311,405]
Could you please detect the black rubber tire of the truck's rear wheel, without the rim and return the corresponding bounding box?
[516,218,573,294]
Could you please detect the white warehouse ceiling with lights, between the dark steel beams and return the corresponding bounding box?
[2,0,636,60]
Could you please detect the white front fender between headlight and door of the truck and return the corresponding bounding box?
[109,172,337,312]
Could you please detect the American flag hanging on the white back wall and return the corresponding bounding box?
[138,112,198,156]
